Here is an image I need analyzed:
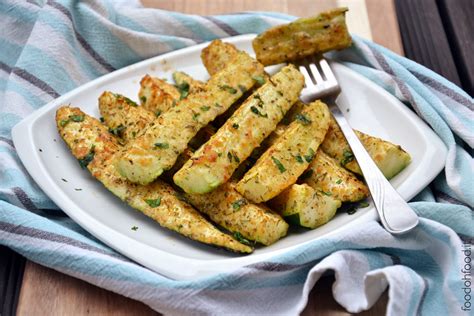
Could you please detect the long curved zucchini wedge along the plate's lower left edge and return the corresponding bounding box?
[56,106,252,253]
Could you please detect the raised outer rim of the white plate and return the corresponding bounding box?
[12,34,447,280]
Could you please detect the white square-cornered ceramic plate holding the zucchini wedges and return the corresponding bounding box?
[12,35,447,279]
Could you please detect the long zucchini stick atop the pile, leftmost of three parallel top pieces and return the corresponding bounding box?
[117,52,263,184]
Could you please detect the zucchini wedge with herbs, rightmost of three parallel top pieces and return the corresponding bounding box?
[237,101,331,203]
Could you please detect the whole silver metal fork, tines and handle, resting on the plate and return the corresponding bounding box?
[299,59,418,234]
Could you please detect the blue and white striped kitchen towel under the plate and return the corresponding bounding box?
[0,0,474,315]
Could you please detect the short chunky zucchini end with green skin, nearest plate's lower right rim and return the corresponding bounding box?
[268,184,341,229]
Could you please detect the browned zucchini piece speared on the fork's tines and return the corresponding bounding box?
[252,8,352,66]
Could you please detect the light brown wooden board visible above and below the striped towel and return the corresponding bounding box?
[17,0,403,316]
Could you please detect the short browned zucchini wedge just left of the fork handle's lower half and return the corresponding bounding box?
[303,148,369,202]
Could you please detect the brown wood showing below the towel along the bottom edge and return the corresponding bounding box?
[17,261,388,316]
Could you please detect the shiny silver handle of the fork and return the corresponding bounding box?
[329,99,418,234]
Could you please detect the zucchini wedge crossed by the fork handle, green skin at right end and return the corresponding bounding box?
[321,117,411,180]
